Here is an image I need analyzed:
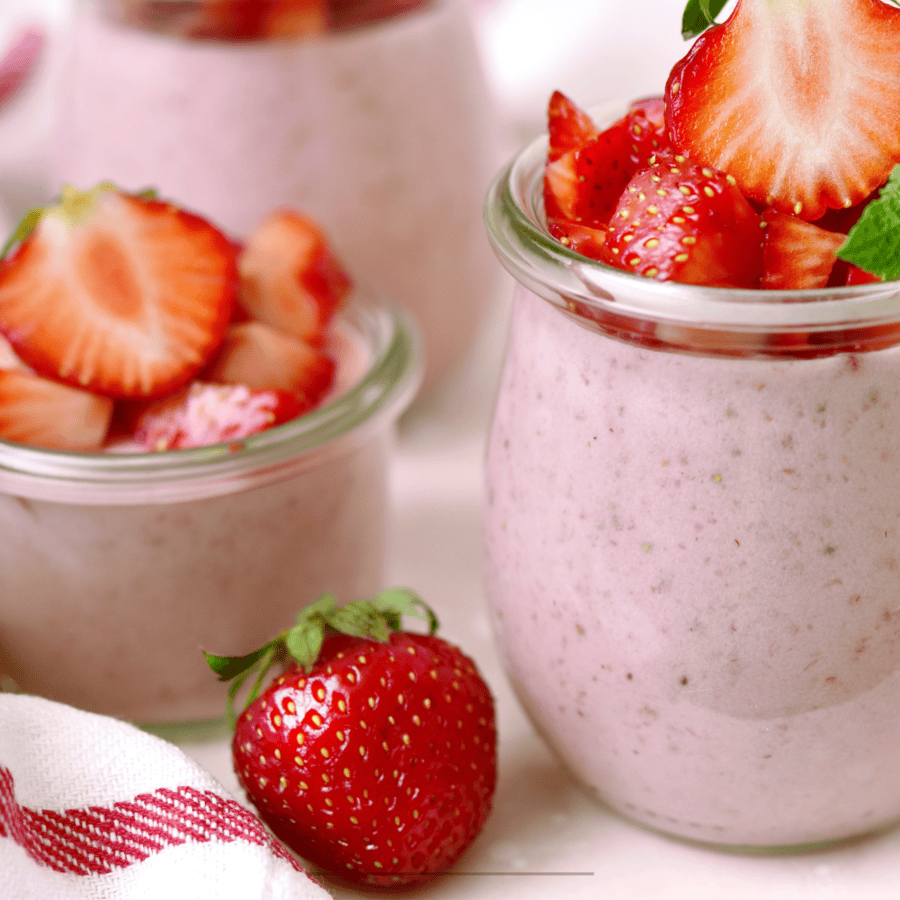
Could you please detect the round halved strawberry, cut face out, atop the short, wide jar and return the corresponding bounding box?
[0,185,238,397]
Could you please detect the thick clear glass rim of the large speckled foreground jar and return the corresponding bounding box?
[484,102,900,333]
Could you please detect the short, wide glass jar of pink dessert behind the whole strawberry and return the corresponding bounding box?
[0,296,420,730]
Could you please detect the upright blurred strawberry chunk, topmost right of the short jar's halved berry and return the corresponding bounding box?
[239,211,353,342]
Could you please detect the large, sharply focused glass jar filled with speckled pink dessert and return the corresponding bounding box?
[483,114,900,847]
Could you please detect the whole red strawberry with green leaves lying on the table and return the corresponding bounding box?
[207,590,496,889]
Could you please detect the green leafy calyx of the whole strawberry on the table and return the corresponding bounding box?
[204,588,438,720]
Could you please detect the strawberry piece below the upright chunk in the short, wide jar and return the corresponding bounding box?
[203,322,336,411]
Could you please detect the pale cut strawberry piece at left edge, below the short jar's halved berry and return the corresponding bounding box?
[0,369,113,451]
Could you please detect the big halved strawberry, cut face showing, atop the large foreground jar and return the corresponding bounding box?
[666,0,900,220]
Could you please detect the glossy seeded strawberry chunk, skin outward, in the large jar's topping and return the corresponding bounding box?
[601,154,762,288]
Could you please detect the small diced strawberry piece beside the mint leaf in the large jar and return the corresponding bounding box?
[760,209,845,290]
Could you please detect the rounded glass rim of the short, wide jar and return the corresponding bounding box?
[0,290,423,505]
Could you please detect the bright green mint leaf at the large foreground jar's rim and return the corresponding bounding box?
[837,165,900,281]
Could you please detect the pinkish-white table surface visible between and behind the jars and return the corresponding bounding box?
[0,0,900,900]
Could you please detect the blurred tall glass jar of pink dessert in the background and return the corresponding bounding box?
[49,0,500,390]
